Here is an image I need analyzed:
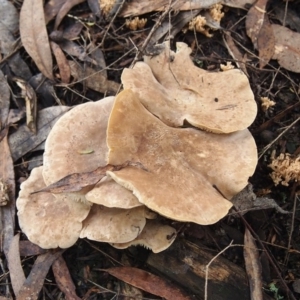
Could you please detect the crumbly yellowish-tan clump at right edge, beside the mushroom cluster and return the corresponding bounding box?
[269,153,300,186]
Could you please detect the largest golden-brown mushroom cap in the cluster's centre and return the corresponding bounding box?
[107,90,257,225]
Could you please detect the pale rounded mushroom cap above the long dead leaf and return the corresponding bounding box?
[43,97,114,185]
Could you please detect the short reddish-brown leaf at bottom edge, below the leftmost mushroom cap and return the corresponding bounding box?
[52,255,81,300]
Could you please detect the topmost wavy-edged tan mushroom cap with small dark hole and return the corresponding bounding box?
[122,43,257,133]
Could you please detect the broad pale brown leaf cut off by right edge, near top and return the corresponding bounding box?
[272,24,300,73]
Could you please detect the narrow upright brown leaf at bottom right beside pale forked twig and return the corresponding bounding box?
[244,228,263,300]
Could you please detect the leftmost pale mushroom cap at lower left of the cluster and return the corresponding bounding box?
[17,167,90,249]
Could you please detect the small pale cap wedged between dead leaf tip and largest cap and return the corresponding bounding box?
[85,176,143,209]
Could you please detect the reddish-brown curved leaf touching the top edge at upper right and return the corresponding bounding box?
[246,0,275,68]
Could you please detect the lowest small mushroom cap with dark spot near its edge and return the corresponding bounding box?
[111,220,176,253]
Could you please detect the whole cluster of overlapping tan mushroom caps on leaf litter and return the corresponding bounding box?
[17,43,257,252]
